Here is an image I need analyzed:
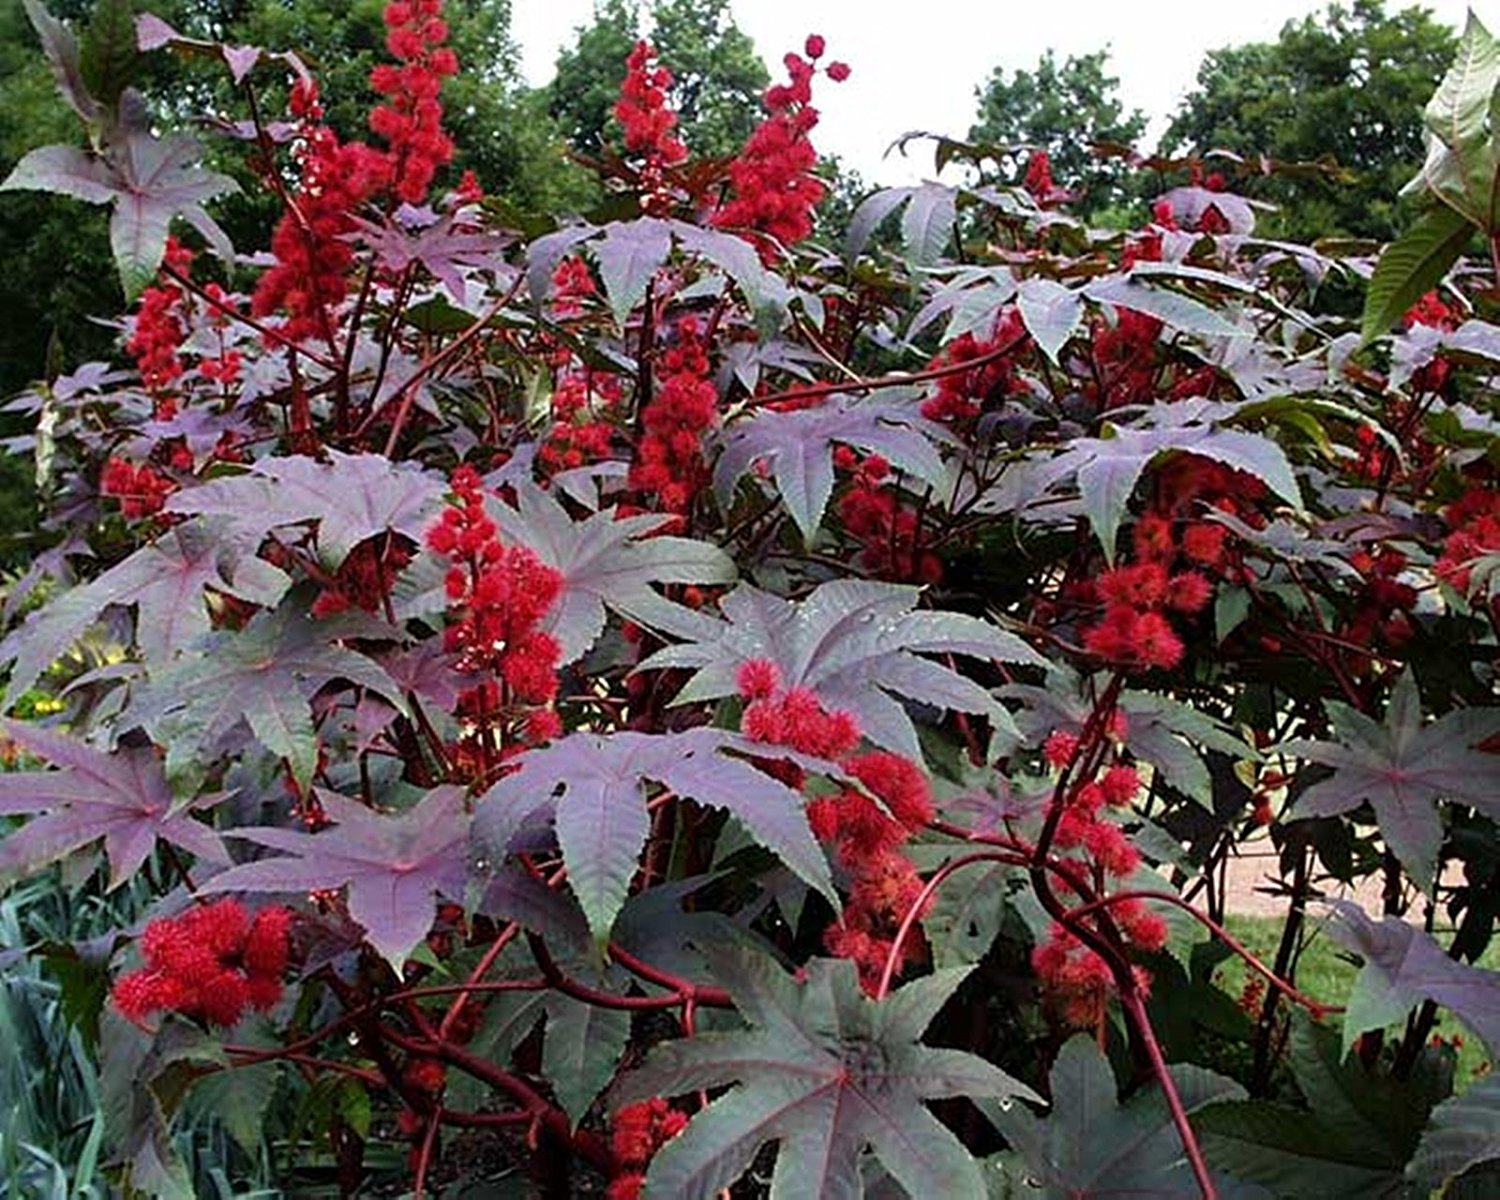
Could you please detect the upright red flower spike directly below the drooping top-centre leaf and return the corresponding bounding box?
[627,317,719,524]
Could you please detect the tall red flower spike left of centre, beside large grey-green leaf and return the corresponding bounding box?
[428,467,563,779]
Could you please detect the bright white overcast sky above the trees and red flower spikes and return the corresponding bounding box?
[512,0,1476,185]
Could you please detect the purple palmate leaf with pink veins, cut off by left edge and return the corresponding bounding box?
[0,720,230,888]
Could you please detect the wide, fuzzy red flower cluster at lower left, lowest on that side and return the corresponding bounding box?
[111,899,293,1026]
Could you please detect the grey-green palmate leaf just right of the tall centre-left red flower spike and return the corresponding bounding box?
[488,482,735,663]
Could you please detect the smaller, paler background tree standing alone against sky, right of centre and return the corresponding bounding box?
[969,50,1146,218]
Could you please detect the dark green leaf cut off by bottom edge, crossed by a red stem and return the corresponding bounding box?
[980,1035,1259,1200]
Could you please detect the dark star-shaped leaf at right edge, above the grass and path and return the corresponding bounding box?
[1283,672,1500,891]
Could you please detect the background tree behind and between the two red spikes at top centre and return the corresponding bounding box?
[548,0,771,156]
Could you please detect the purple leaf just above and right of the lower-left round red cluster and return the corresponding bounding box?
[203,786,470,974]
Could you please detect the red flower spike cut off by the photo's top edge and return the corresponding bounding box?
[371,0,459,204]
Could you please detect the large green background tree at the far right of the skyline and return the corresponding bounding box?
[1163,0,1455,240]
